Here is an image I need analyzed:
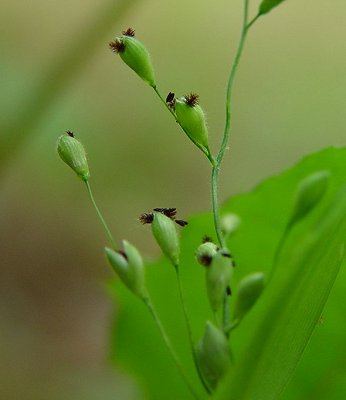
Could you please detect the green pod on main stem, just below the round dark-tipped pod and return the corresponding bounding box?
[205,252,233,313]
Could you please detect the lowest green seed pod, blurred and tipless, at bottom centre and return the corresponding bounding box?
[195,321,231,390]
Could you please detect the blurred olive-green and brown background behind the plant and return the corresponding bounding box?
[0,0,346,400]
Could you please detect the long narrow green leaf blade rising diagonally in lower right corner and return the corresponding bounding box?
[217,188,346,400]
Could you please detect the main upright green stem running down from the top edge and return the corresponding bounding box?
[211,0,258,329]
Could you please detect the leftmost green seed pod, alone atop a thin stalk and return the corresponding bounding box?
[57,131,90,182]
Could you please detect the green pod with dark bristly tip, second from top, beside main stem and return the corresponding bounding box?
[175,93,209,149]
